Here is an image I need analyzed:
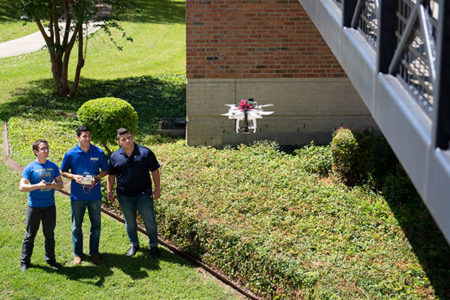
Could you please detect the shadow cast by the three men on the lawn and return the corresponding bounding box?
[31,248,194,287]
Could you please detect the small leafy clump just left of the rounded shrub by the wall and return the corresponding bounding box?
[294,141,331,176]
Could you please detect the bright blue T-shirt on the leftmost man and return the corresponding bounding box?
[22,160,60,207]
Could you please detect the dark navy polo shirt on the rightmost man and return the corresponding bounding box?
[109,143,160,196]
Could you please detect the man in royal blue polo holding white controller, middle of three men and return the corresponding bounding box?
[61,125,109,265]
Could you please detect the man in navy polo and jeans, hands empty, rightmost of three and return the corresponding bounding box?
[107,128,160,258]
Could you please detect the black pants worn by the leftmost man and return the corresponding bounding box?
[20,205,56,264]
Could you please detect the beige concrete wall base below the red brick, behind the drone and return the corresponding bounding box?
[187,78,376,146]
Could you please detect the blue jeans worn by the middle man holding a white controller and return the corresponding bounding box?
[70,199,102,257]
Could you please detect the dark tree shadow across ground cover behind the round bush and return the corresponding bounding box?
[0,74,186,134]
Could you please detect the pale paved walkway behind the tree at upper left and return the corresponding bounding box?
[0,4,111,58]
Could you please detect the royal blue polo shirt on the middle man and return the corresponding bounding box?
[61,144,109,201]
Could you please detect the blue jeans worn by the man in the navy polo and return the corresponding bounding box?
[117,193,158,247]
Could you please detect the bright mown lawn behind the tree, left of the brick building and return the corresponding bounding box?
[0,0,186,103]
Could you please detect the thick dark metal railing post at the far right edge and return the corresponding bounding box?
[433,0,450,149]
